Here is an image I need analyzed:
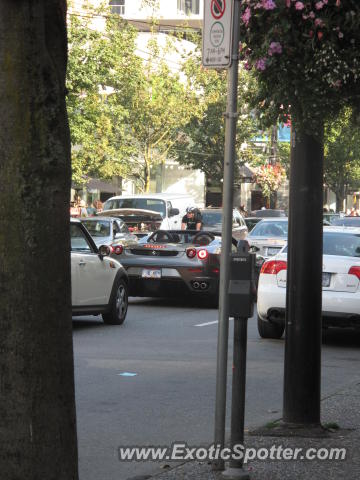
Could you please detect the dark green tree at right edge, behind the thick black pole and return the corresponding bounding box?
[324,108,360,210]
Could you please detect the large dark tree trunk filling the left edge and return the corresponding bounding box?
[0,0,78,480]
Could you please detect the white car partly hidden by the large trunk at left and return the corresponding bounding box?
[70,218,128,325]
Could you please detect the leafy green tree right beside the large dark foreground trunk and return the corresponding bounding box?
[67,5,141,184]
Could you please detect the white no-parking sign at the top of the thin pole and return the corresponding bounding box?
[202,0,234,68]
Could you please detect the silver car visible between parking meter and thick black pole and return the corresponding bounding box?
[247,217,288,259]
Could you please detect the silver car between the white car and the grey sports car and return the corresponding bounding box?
[80,216,138,247]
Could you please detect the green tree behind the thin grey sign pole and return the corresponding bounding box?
[172,47,256,186]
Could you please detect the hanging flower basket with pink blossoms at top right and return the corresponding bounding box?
[240,0,360,133]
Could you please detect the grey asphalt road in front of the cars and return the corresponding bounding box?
[74,299,360,480]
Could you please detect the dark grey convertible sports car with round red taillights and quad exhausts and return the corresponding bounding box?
[112,230,237,304]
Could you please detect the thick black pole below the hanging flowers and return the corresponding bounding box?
[283,129,323,427]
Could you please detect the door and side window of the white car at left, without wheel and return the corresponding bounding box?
[71,224,117,306]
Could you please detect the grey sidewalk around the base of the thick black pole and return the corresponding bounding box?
[142,379,360,480]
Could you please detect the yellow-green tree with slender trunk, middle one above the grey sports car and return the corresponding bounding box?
[129,33,196,191]
